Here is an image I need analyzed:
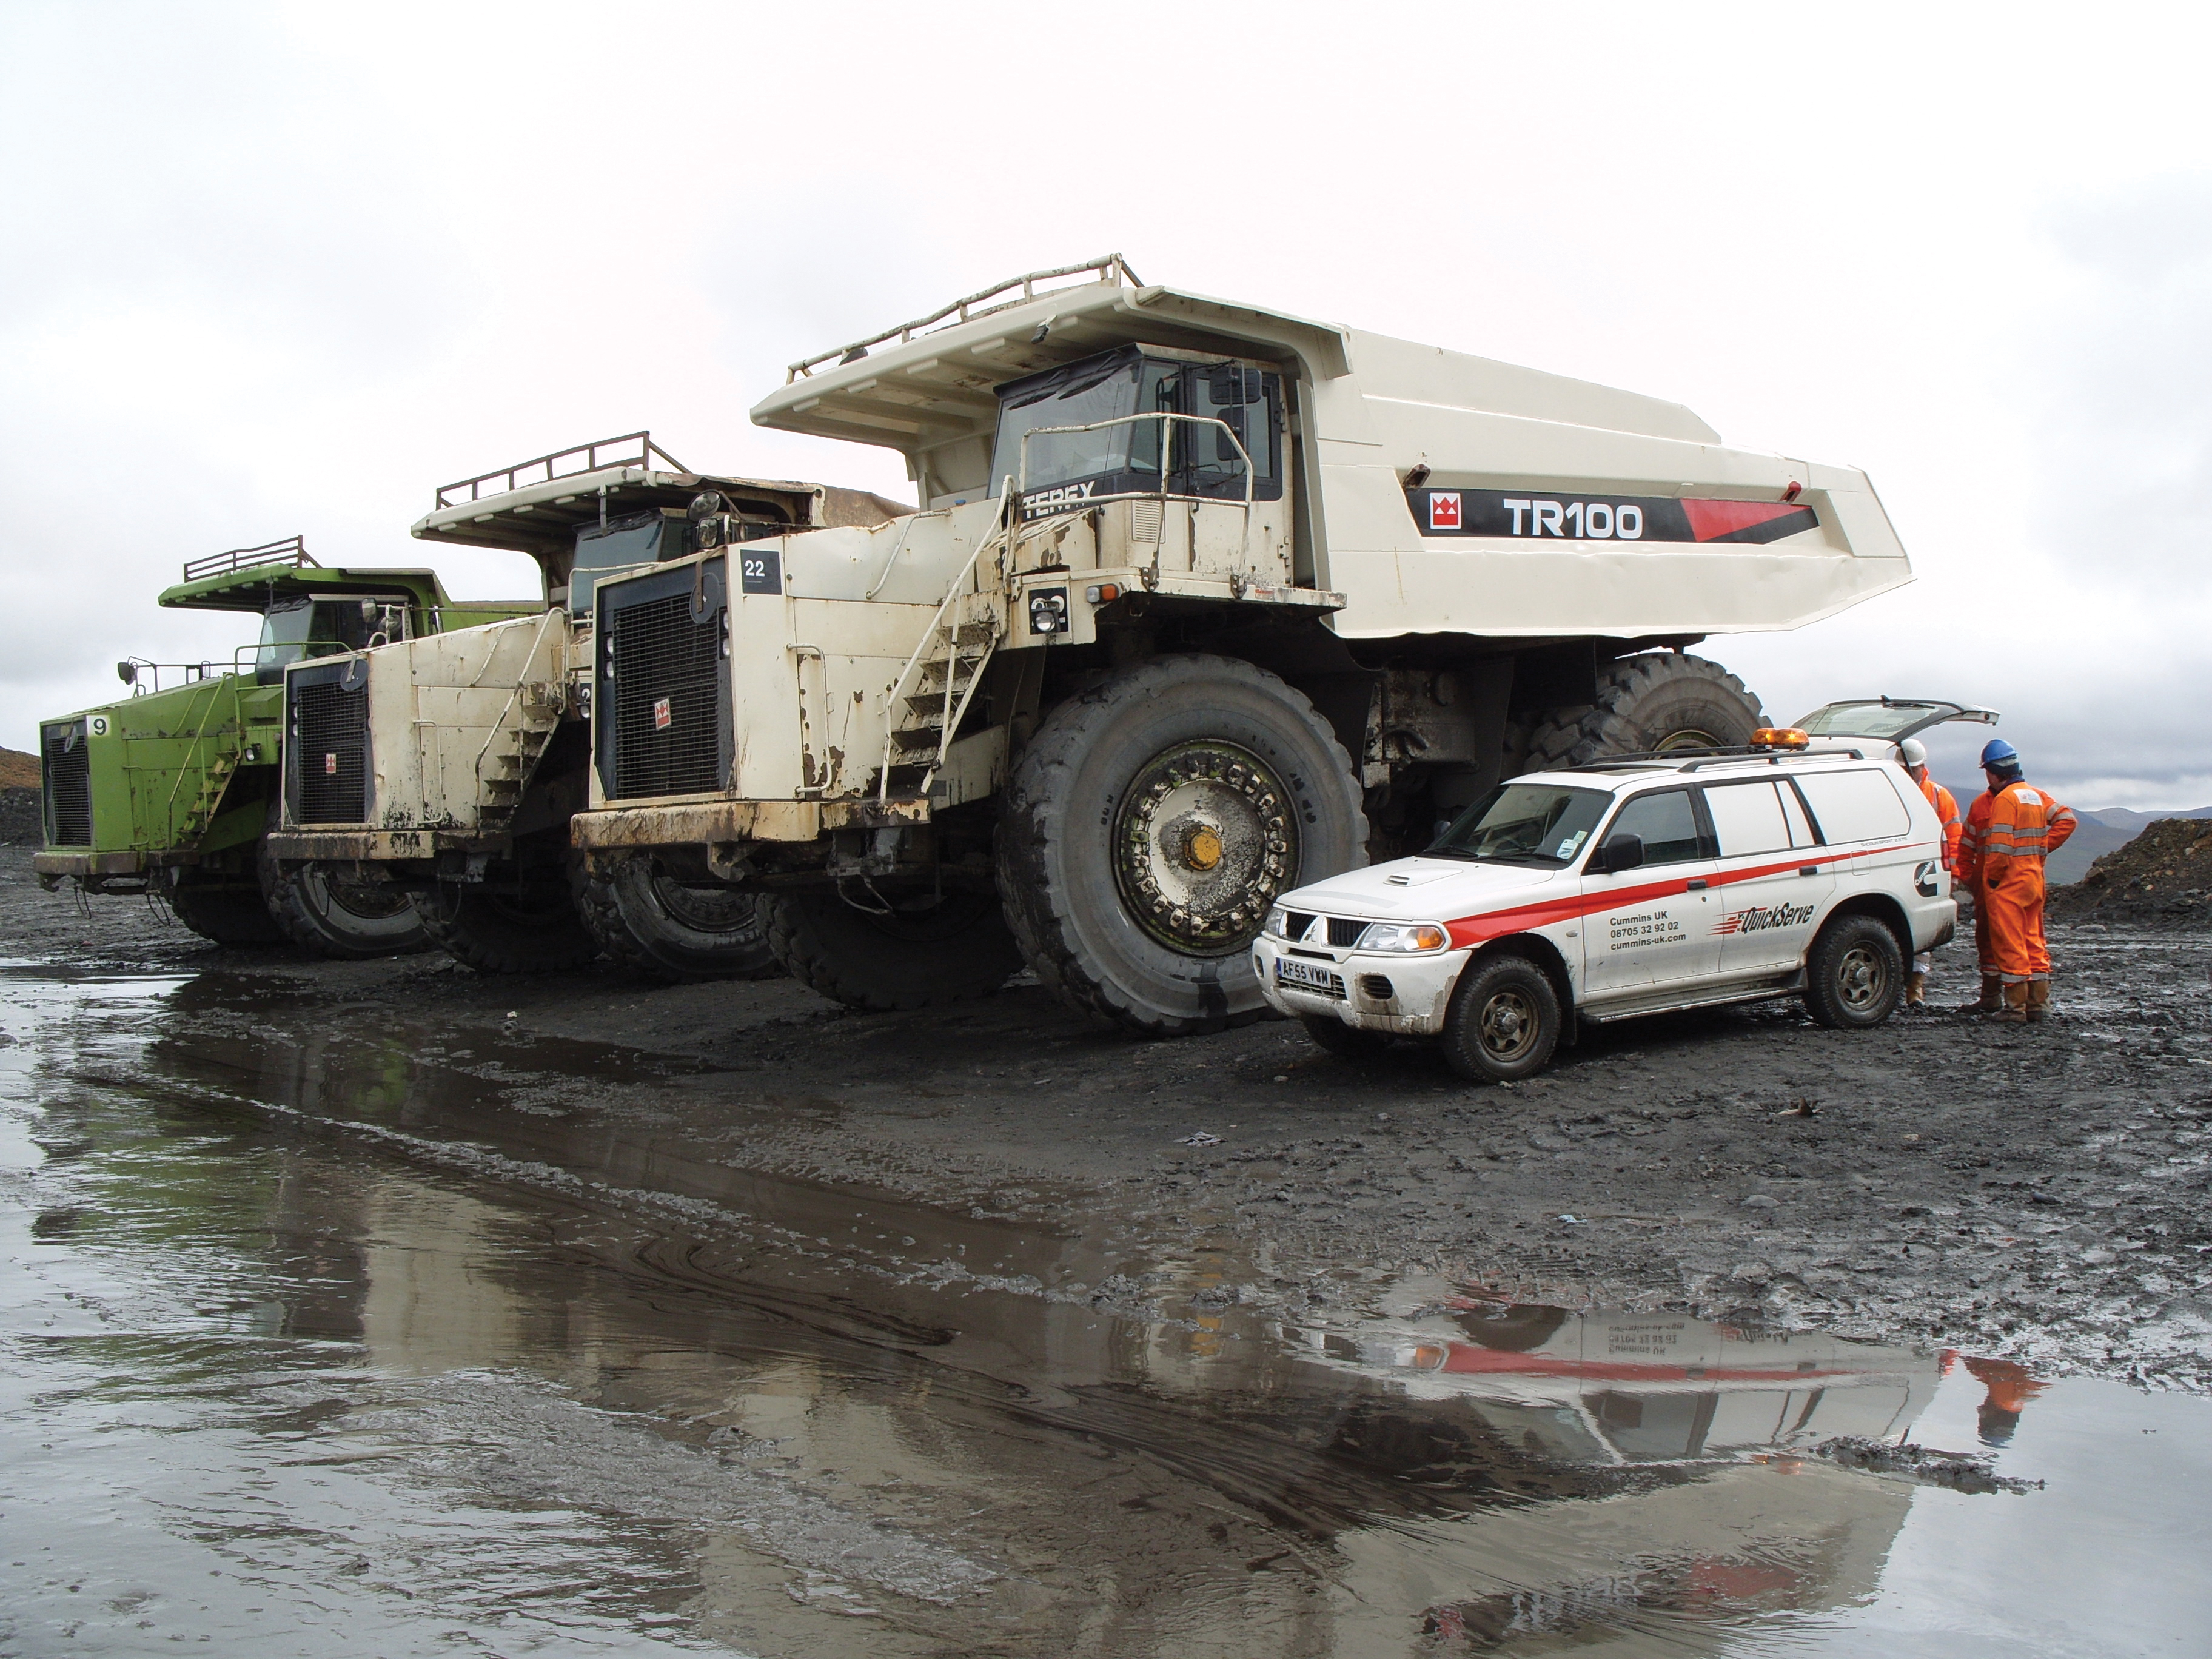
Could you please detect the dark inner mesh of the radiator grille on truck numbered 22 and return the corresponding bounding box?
[600,588,728,801]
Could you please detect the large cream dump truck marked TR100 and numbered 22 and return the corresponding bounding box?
[575,256,1911,1035]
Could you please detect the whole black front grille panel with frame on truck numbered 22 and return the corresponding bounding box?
[597,560,730,801]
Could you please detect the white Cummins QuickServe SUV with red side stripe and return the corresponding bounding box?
[1252,734,1957,1082]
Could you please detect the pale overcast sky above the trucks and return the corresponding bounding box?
[0,0,2212,808]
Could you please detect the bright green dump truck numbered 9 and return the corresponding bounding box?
[31,535,537,956]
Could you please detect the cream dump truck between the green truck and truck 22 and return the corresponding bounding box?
[270,431,907,977]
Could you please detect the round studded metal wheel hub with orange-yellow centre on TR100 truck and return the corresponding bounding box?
[1113,741,1298,956]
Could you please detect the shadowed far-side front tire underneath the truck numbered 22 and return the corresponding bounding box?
[763,889,1022,1013]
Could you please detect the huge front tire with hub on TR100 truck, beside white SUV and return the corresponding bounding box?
[997,655,1367,1037]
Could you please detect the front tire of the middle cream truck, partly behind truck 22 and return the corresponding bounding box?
[571,854,783,984]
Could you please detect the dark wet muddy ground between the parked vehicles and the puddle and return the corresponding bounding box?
[0,847,2212,1392]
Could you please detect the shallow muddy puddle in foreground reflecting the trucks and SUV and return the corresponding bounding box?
[0,969,2205,1659]
